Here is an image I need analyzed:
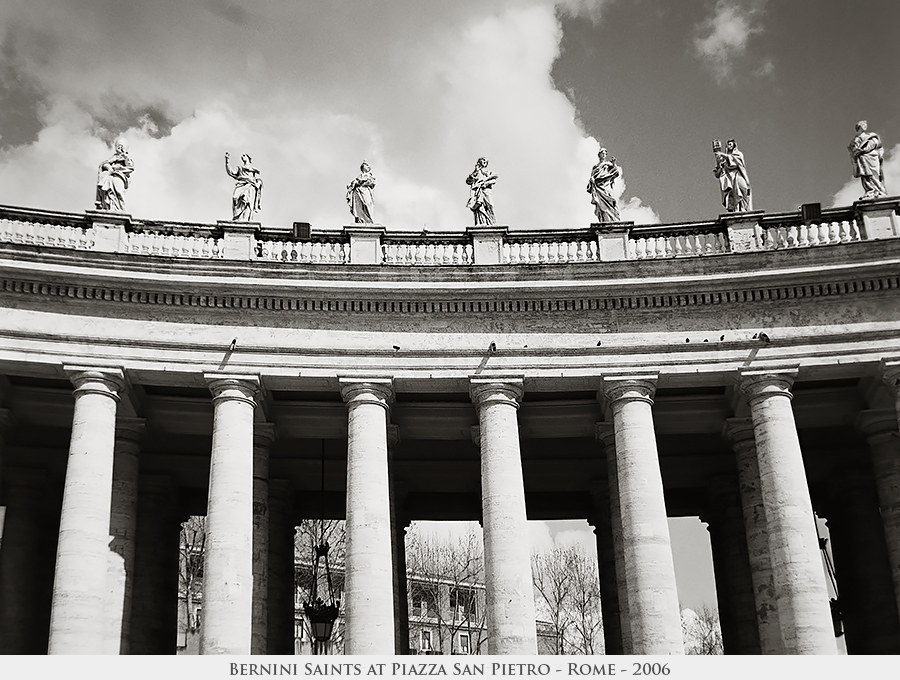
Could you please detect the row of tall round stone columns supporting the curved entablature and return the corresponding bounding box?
[0,361,900,654]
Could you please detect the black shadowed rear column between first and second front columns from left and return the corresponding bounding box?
[129,474,181,654]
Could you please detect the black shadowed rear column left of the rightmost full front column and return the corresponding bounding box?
[703,475,761,654]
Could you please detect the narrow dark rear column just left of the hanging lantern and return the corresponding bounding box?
[266,479,294,654]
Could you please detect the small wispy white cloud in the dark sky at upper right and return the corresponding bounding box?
[694,0,775,85]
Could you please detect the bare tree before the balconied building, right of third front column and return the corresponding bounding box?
[406,524,487,654]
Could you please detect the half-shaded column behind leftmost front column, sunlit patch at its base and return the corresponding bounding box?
[105,418,145,654]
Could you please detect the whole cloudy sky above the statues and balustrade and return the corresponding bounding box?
[0,0,900,230]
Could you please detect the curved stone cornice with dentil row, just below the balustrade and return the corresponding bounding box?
[0,242,900,314]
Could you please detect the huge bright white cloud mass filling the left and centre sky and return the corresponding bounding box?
[0,0,652,230]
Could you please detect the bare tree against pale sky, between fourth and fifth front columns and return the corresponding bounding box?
[531,547,603,654]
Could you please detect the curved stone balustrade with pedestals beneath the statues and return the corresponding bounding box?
[0,198,900,266]
